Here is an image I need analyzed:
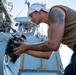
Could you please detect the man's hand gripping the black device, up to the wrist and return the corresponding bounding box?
[13,38,27,55]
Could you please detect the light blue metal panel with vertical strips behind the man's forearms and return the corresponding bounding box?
[20,36,64,70]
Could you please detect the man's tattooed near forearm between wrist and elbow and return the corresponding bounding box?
[27,40,56,52]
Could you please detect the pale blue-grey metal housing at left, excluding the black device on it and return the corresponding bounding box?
[0,33,20,75]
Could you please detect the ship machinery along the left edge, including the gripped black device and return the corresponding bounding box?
[0,0,25,75]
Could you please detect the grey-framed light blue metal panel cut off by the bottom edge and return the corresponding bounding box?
[18,69,62,75]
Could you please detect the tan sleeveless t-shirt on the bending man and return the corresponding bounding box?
[51,5,76,49]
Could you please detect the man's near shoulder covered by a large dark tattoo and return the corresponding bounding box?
[48,6,65,25]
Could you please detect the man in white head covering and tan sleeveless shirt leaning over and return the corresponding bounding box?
[14,3,76,75]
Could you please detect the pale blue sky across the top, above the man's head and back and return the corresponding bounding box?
[10,0,76,18]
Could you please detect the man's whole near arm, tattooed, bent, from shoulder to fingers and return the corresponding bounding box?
[14,7,65,54]
